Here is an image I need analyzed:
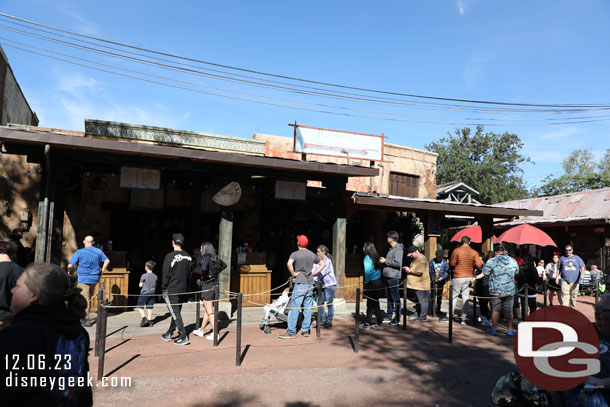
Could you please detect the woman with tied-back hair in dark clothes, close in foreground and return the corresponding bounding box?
[0,263,93,406]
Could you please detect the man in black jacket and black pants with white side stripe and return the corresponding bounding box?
[161,233,193,345]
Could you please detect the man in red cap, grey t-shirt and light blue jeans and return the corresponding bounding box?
[279,235,326,339]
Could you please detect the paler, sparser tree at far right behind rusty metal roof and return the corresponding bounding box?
[533,148,610,196]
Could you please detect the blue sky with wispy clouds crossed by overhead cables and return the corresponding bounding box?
[0,0,610,185]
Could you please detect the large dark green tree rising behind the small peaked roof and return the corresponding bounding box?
[426,126,531,204]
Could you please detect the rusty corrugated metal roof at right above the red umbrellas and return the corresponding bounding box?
[494,188,610,225]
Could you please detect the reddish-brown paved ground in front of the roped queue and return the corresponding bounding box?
[90,297,594,407]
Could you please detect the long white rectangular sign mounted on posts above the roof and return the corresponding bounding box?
[294,126,383,161]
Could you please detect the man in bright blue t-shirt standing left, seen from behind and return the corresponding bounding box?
[68,236,110,326]
